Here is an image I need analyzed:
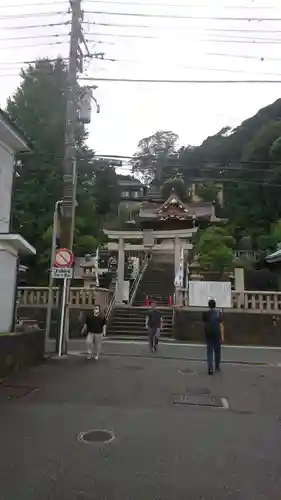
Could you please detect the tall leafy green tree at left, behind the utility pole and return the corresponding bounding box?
[7,59,118,278]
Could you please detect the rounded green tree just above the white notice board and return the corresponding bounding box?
[196,226,235,274]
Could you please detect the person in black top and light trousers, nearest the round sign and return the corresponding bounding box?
[82,305,106,361]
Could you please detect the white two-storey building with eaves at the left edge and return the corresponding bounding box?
[0,110,36,333]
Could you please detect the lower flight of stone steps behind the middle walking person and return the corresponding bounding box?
[108,306,173,337]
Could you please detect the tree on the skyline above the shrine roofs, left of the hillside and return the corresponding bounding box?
[131,130,178,186]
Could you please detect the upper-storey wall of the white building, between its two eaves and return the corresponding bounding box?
[0,142,14,233]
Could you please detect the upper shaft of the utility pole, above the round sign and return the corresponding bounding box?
[60,0,82,250]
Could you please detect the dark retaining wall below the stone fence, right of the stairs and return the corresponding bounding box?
[173,310,281,346]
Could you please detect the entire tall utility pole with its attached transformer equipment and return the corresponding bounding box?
[53,0,100,354]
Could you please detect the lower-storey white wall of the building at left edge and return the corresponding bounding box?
[0,250,17,333]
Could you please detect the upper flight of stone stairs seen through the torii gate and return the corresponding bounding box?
[133,260,174,307]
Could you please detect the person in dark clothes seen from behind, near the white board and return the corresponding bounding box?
[203,299,224,375]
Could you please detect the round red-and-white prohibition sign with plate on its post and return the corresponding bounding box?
[52,248,74,357]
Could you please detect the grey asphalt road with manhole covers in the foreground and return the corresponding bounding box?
[0,346,281,500]
